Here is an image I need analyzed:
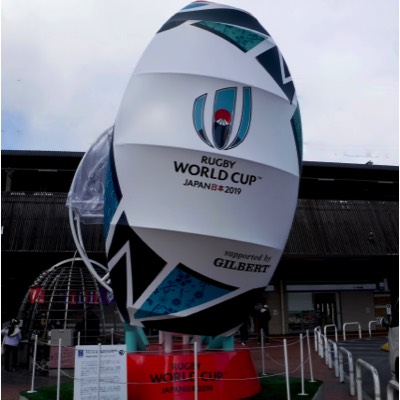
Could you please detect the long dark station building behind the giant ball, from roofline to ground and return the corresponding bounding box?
[1,150,399,335]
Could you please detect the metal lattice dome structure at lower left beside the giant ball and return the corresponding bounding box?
[18,257,124,344]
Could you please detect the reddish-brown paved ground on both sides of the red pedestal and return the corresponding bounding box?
[1,337,394,400]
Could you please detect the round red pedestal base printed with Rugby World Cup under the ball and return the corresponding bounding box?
[127,349,261,400]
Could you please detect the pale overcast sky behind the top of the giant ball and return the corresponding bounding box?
[1,0,399,165]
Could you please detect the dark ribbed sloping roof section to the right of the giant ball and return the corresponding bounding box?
[284,199,399,257]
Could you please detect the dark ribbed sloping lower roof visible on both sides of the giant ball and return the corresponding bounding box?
[1,192,399,257]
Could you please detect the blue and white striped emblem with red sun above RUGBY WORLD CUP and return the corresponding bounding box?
[193,86,251,150]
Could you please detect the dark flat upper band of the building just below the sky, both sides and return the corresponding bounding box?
[1,150,399,201]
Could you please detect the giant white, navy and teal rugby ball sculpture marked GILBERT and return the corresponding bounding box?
[75,1,302,336]
